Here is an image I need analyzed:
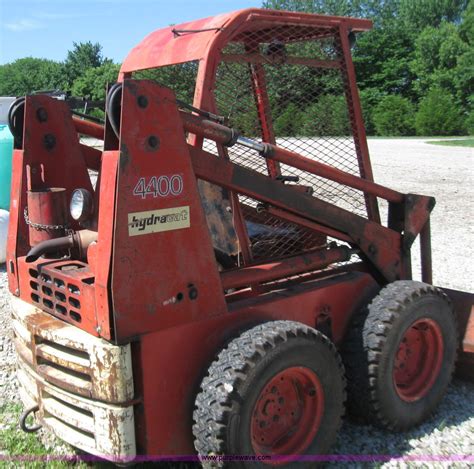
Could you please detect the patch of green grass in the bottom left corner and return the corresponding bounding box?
[0,404,88,469]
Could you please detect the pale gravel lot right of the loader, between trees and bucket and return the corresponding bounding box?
[369,139,474,292]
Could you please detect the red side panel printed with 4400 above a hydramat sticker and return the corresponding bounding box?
[111,80,227,342]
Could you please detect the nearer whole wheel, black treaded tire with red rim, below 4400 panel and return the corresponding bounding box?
[193,321,345,468]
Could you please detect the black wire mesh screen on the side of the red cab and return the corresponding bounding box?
[208,26,367,258]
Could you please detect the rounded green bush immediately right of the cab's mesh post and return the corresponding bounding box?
[372,95,415,137]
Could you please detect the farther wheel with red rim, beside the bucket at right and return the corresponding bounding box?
[341,281,458,431]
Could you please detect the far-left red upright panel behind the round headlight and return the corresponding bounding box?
[7,95,92,296]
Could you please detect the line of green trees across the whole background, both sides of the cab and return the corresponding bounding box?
[0,0,474,136]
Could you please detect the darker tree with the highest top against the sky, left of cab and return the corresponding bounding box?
[64,41,105,88]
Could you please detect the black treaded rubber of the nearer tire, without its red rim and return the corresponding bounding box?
[193,321,345,468]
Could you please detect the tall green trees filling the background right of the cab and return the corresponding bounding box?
[263,0,474,136]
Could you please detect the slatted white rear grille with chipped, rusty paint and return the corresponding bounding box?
[11,297,136,462]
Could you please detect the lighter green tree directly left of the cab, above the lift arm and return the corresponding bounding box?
[71,62,120,100]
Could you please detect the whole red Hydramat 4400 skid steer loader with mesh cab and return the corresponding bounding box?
[7,9,473,467]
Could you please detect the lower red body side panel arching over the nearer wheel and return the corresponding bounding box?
[134,273,378,455]
